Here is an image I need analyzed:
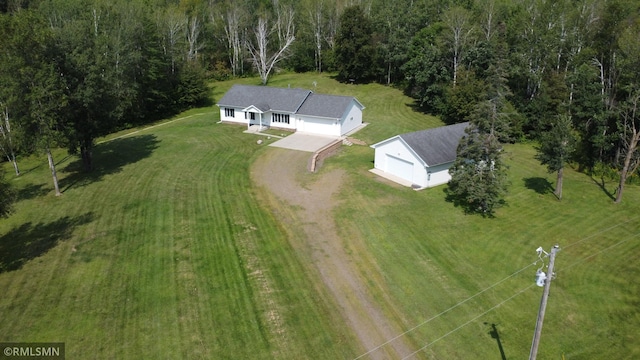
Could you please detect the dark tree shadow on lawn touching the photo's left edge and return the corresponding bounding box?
[0,213,93,273]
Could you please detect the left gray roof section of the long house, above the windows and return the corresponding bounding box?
[218,85,311,113]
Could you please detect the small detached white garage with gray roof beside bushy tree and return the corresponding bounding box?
[371,123,469,188]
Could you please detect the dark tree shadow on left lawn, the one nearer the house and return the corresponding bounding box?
[60,135,160,192]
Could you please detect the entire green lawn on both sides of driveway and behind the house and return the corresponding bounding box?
[0,74,640,359]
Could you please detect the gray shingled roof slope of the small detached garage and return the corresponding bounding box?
[399,122,469,166]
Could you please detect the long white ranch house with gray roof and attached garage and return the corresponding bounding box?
[218,85,364,137]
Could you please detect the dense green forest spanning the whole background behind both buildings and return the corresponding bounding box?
[0,0,640,208]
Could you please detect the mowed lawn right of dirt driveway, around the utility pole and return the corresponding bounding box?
[328,144,640,359]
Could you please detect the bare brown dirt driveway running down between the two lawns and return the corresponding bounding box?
[251,149,413,359]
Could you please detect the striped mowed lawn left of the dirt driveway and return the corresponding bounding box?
[0,109,356,359]
